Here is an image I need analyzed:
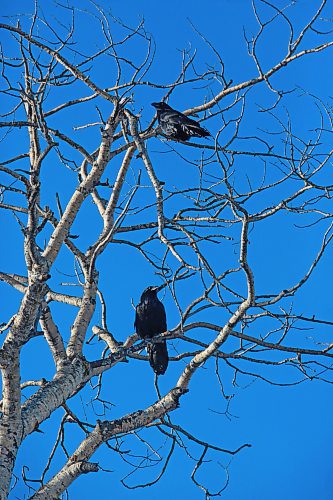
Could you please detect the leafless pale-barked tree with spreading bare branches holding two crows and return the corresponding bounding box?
[0,0,333,499]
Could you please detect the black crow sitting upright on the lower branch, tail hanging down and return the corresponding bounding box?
[134,286,169,375]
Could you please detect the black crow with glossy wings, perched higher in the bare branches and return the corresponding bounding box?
[151,102,210,141]
